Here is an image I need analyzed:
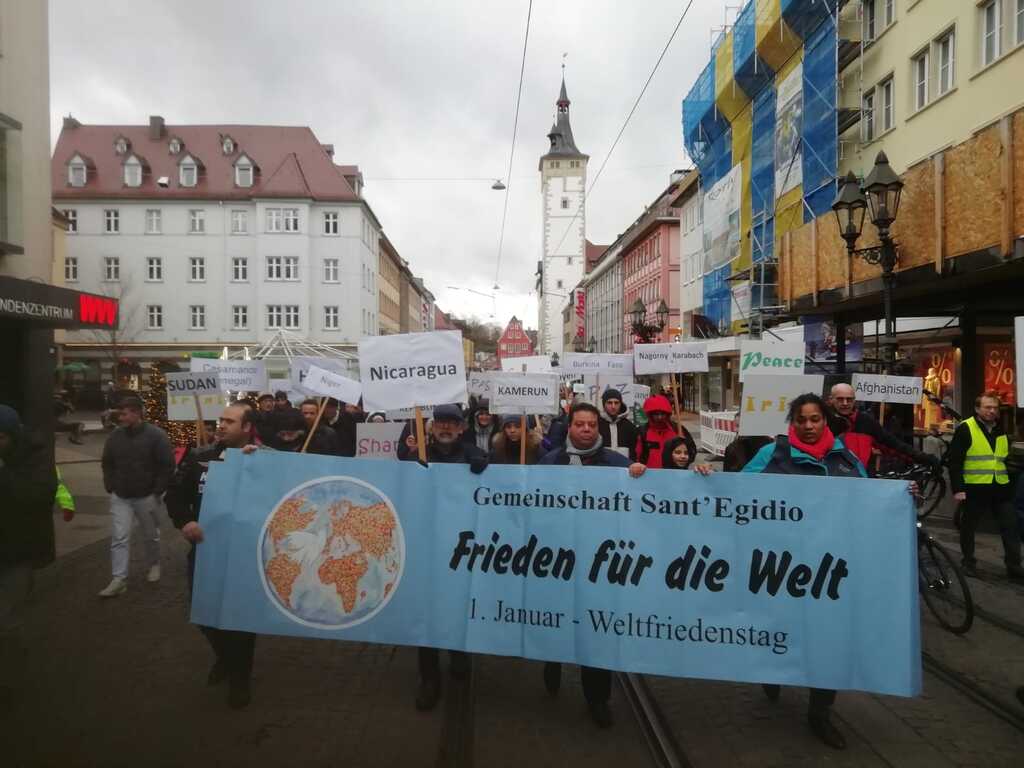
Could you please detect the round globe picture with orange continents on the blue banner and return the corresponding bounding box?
[258,477,406,630]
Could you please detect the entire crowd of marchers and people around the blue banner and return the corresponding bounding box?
[0,384,1024,749]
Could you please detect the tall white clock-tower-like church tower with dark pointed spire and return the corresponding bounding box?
[537,79,589,354]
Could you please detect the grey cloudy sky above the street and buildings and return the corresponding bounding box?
[50,0,720,327]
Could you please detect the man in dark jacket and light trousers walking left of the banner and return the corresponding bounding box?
[99,396,174,597]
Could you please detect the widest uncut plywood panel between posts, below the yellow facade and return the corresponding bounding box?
[942,125,1002,258]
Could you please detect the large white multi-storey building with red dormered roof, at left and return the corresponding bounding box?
[53,118,381,359]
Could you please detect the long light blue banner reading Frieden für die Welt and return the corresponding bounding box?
[191,451,921,695]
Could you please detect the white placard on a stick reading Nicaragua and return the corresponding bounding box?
[359,331,468,411]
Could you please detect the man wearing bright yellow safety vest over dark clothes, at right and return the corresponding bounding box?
[946,393,1024,579]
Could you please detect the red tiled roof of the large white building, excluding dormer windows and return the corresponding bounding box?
[56,125,359,202]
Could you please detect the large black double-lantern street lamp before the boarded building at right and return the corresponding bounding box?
[833,152,903,374]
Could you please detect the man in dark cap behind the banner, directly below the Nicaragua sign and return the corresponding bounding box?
[397,406,487,711]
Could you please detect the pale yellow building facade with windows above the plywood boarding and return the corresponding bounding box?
[840,0,1024,176]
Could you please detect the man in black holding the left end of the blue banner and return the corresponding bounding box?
[167,404,256,709]
